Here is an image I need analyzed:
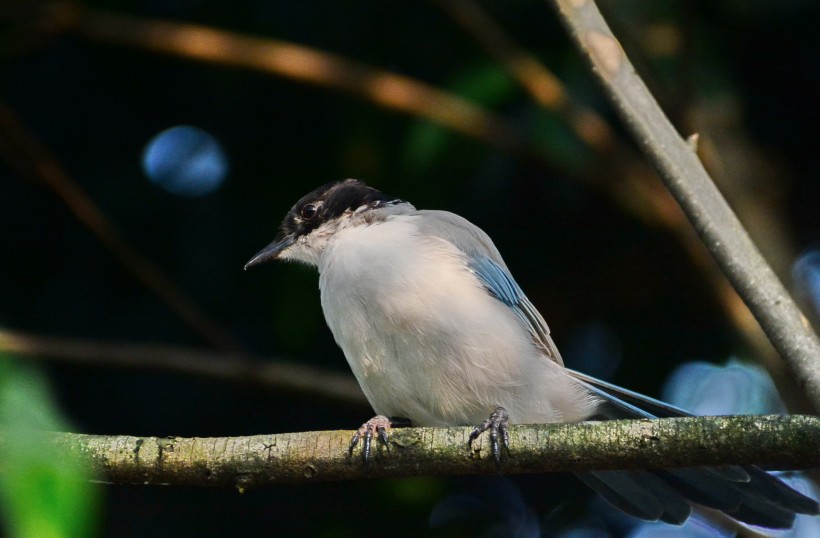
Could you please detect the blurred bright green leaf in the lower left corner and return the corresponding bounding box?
[0,357,100,538]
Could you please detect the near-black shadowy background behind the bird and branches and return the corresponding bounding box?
[0,0,820,536]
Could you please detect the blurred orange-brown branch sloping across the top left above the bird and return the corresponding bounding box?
[77,11,544,160]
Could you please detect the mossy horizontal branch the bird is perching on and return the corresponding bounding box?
[35,415,820,489]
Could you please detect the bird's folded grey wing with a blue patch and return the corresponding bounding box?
[419,211,564,365]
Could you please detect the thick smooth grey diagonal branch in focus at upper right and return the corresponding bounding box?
[552,0,820,411]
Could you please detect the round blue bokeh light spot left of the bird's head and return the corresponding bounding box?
[142,125,228,196]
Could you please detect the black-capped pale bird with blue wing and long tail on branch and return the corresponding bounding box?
[245,179,820,529]
